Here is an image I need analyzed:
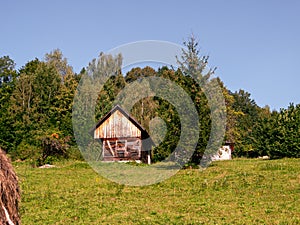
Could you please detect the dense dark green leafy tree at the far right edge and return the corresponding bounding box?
[253,104,300,158]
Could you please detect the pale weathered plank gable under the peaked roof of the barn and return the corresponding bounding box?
[94,110,141,138]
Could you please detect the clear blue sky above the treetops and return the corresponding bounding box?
[0,0,300,109]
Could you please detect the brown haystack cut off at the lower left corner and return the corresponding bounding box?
[0,148,21,225]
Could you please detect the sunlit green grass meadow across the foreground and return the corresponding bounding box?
[14,159,300,225]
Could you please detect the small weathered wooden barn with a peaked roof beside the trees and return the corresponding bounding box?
[93,105,153,164]
